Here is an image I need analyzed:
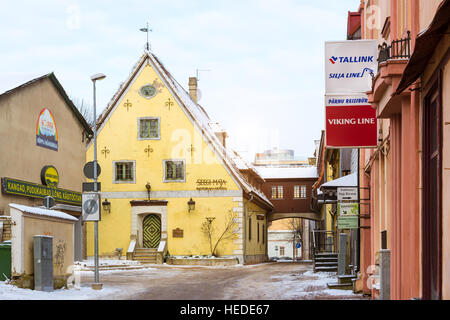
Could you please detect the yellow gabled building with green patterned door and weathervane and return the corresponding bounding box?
[87,51,273,263]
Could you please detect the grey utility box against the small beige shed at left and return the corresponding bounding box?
[33,236,53,292]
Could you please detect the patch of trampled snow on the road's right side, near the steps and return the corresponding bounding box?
[271,271,360,299]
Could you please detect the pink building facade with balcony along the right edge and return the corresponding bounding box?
[359,0,450,299]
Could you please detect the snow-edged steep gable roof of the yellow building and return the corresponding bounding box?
[97,51,273,209]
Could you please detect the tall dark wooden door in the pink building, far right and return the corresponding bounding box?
[422,80,442,300]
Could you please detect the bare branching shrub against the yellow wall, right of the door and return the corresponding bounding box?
[202,212,237,257]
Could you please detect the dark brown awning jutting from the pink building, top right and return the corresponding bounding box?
[395,0,450,94]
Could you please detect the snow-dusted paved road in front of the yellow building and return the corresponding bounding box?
[83,263,362,300]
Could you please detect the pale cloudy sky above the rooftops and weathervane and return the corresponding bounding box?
[0,0,359,160]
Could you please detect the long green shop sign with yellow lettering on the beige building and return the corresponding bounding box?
[2,178,81,206]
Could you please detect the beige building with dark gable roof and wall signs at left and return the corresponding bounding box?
[0,73,92,259]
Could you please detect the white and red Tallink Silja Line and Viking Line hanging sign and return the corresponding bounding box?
[325,40,378,148]
